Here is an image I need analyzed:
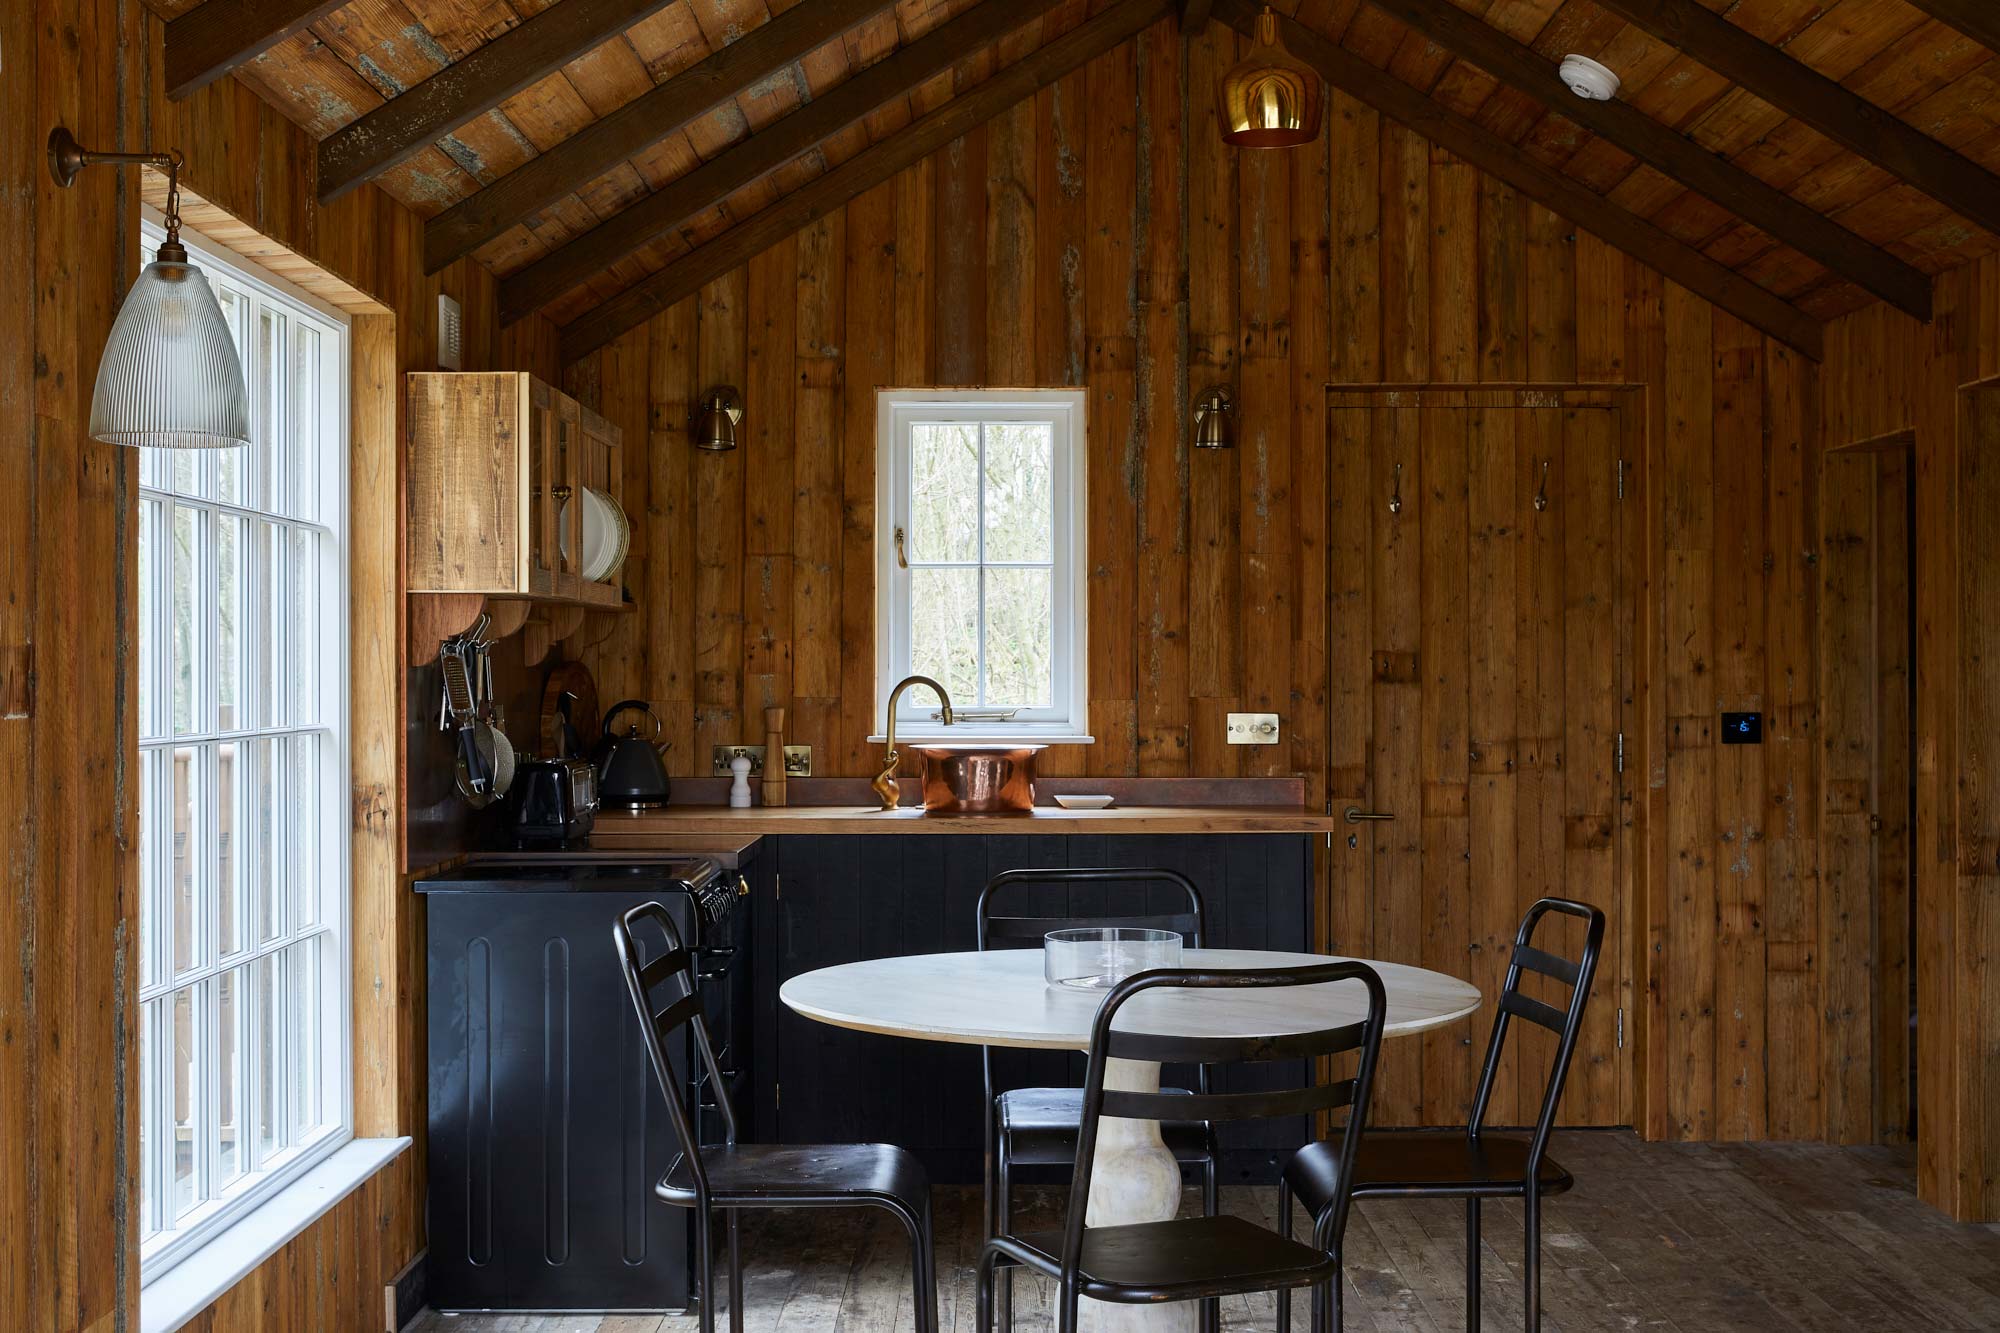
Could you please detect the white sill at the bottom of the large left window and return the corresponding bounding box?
[138,1137,410,1333]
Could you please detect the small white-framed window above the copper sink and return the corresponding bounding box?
[876,388,1090,743]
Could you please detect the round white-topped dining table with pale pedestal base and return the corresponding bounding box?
[778,949,1480,1333]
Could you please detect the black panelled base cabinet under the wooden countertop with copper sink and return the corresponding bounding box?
[756,835,1312,1183]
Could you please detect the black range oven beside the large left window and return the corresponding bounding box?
[416,855,754,1311]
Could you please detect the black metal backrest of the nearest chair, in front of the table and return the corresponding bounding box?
[1062,961,1388,1273]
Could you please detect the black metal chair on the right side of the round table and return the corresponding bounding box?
[1278,899,1604,1333]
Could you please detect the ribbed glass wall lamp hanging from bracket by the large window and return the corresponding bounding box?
[48,128,250,448]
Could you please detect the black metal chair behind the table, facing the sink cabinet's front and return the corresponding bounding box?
[978,867,1222,1333]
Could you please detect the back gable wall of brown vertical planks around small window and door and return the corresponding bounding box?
[568,24,1840,1139]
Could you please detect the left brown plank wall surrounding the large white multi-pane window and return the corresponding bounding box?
[0,0,556,1331]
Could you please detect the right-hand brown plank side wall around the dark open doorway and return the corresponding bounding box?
[1820,258,2000,1219]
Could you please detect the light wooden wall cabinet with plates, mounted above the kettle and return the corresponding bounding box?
[408,370,624,606]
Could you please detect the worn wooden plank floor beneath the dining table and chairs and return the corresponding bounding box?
[412,1131,2000,1333]
